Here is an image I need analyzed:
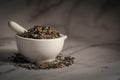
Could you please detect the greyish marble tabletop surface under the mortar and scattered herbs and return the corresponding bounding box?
[0,38,120,80]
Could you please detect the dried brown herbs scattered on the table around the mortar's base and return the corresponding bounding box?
[9,53,74,70]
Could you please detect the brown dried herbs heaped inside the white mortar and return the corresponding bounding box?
[18,25,60,39]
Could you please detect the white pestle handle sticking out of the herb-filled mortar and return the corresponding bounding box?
[8,21,27,34]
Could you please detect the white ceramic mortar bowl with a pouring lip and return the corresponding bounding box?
[16,34,67,63]
